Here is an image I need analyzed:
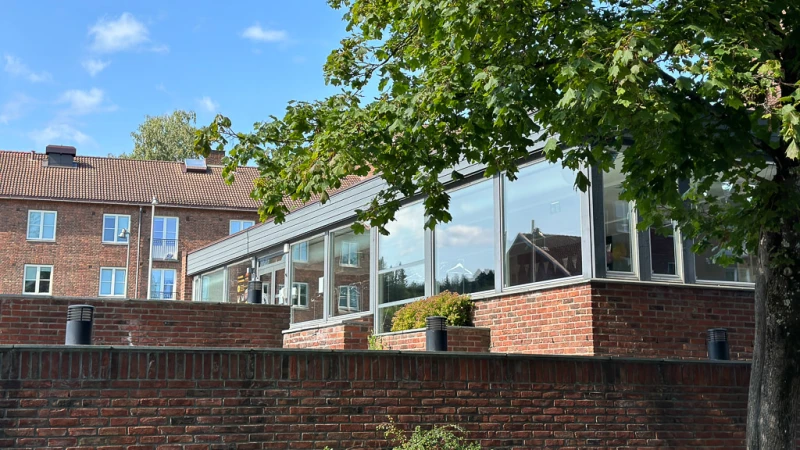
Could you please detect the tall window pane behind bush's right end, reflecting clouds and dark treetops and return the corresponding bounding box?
[435,181,495,294]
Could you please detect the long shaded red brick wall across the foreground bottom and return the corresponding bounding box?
[0,348,749,450]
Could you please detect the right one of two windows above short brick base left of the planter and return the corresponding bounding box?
[331,228,371,316]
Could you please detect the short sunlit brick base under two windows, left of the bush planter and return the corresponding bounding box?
[283,316,372,350]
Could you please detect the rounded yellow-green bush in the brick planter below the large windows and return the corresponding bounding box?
[392,291,474,331]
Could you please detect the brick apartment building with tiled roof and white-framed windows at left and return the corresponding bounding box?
[0,146,258,299]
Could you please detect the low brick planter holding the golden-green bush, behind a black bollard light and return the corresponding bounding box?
[380,327,492,353]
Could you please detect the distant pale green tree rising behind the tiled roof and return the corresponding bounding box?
[126,110,202,161]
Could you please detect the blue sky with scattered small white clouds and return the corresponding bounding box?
[0,0,354,156]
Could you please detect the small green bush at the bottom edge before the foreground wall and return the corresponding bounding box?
[379,421,481,450]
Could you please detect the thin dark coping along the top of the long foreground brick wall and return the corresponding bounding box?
[0,344,751,366]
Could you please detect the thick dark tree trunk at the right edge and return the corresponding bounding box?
[747,227,800,450]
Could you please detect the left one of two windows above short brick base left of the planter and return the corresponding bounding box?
[290,236,325,323]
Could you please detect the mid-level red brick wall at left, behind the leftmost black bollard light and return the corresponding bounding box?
[0,296,289,348]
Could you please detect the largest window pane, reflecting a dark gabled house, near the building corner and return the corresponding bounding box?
[503,162,583,286]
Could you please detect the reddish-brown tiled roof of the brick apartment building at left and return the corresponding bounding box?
[0,151,374,210]
